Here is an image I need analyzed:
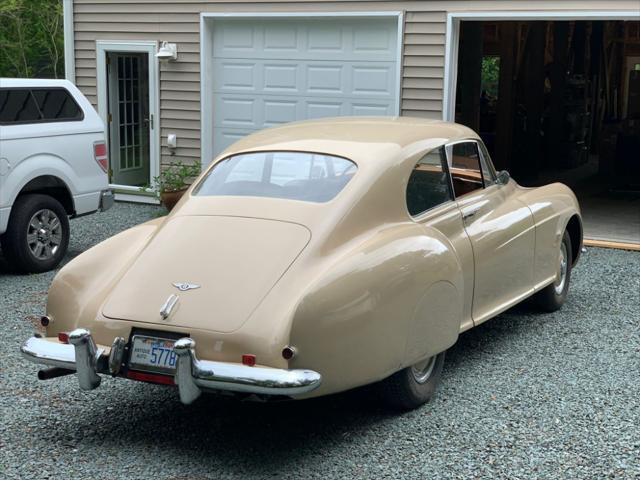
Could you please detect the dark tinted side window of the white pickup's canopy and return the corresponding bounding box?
[0,87,84,125]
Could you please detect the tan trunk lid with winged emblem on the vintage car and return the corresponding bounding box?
[103,215,311,332]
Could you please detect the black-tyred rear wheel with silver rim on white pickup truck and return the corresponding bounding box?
[2,194,69,273]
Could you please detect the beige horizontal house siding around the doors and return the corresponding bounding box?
[73,0,637,164]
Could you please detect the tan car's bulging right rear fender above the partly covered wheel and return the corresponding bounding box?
[290,224,464,395]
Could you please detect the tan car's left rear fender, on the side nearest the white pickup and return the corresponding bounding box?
[47,217,164,336]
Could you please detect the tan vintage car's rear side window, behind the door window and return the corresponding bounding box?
[407,147,453,217]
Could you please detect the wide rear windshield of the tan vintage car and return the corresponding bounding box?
[194,152,357,203]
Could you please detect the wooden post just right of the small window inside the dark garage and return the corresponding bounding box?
[494,22,518,170]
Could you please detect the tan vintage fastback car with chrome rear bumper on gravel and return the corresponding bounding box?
[22,118,582,408]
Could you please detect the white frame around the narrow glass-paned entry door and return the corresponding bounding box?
[96,40,160,198]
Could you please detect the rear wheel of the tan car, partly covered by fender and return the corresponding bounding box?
[378,352,444,410]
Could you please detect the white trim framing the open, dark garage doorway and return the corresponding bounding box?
[442,10,640,122]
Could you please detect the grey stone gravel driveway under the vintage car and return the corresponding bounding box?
[0,204,640,480]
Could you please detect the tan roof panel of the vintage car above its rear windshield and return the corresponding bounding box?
[220,117,478,163]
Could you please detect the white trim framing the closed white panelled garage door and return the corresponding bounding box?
[200,11,404,169]
